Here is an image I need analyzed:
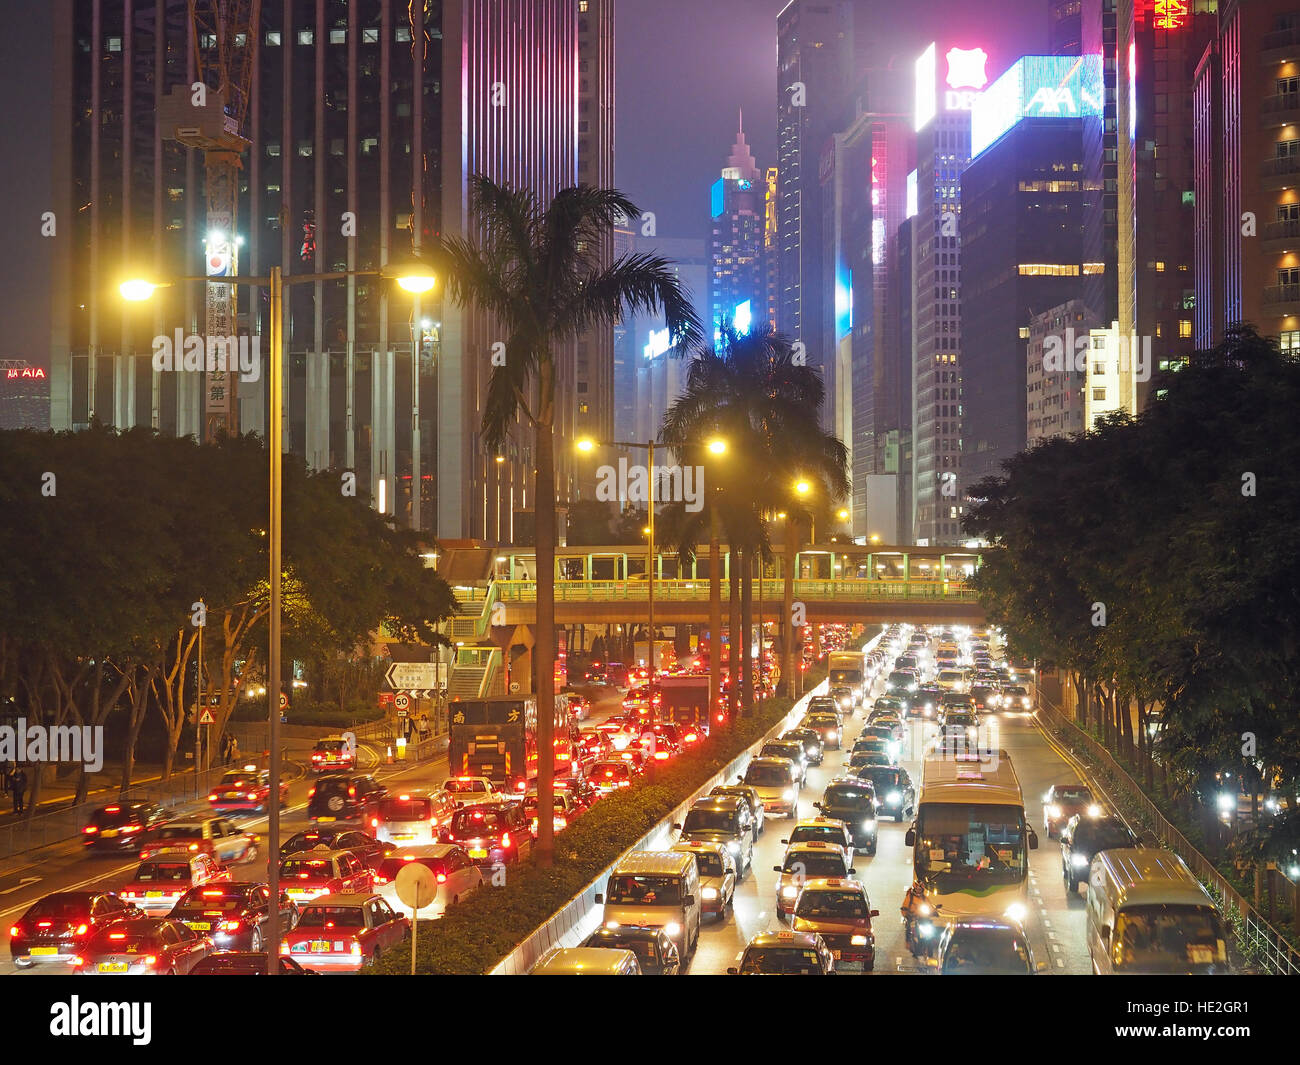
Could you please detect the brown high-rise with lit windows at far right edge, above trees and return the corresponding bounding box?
[1190,0,1300,352]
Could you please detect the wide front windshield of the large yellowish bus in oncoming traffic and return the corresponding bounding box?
[917,804,1027,893]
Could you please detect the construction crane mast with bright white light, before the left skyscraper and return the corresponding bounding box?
[159,0,261,442]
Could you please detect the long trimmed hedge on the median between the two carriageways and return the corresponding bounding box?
[367,670,824,975]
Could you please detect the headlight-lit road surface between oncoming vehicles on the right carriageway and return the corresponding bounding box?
[689,657,1100,975]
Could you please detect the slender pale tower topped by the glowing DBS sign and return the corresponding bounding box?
[909,43,988,545]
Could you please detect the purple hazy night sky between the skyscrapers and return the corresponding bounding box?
[615,0,1048,238]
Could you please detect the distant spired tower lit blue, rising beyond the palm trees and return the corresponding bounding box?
[709,114,767,333]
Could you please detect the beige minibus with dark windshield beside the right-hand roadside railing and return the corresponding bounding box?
[1087,847,1231,975]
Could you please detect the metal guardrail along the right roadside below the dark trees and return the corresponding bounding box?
[1037,693,1300,977]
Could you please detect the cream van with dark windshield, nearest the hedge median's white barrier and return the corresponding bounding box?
[595,850,701,958]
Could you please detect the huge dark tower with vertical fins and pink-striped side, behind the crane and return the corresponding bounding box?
[51,0,612,540]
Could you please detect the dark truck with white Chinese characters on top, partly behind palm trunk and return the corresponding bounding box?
[447,696,573,792]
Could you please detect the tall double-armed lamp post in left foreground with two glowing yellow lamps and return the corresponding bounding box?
[118,263,434,977]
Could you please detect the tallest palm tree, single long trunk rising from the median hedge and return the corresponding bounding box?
[434,174,701,865]
